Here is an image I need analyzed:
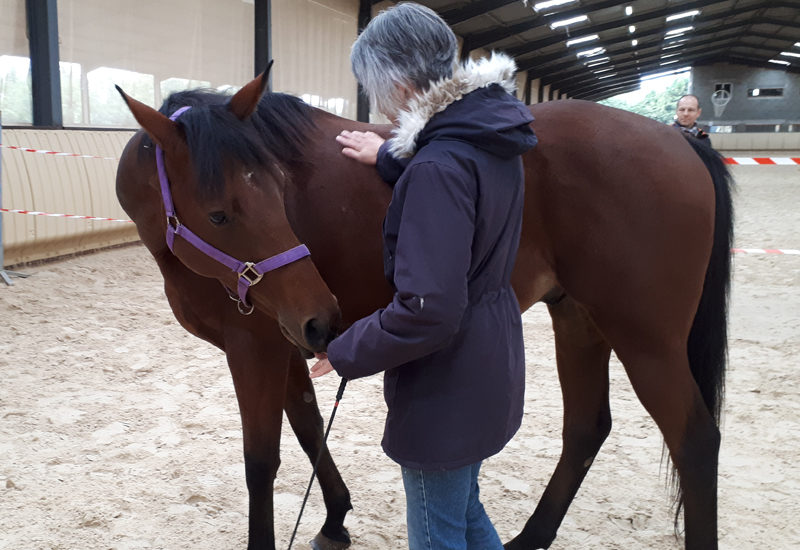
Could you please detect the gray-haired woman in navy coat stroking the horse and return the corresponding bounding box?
[311,3,536,550]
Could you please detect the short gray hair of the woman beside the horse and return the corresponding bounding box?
[350,2,458,117]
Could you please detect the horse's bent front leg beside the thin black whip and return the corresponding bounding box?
[285,350,353,550]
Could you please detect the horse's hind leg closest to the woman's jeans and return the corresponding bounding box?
[505,297,611,550]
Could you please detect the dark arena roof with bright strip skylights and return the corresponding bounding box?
[404,0,800,100]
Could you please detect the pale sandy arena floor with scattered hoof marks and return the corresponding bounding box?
[0,161,800,550]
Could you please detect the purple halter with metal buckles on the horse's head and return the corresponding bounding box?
[156,107,311,315]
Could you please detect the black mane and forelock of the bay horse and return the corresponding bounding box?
[150,89,314,201]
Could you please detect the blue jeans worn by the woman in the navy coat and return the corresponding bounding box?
[402,462,503,550]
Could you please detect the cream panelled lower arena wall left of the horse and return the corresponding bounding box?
[0,129,139,266]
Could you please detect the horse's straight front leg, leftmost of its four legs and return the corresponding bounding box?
[225,326,292,550]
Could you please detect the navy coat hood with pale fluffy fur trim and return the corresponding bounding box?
[387,53,536,158]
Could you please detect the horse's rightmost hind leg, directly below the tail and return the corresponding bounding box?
[615,340,720,550]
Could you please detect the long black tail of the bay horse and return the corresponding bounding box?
[672,135,733,527]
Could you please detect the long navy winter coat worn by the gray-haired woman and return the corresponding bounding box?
[328,80,536,470]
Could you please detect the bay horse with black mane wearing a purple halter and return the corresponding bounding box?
[117,66,732,550]
